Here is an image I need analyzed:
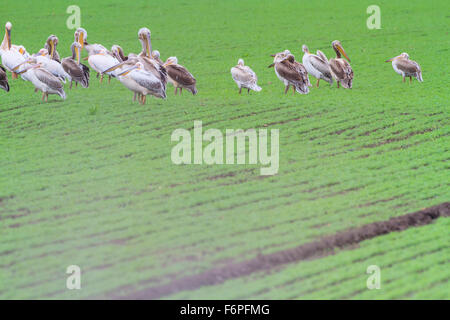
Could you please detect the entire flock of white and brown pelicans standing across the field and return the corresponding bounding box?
[0,22,423,104]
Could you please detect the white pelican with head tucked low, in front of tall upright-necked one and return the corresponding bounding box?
[118,61,166,104]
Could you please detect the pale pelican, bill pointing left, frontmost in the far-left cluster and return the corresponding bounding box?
[18,63,66,101]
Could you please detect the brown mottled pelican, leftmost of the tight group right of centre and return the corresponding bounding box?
[269,50,310,94]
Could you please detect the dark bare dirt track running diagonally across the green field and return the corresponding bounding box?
[110,202,450,299]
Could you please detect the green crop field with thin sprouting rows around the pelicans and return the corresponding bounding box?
[0,0,450,299]
